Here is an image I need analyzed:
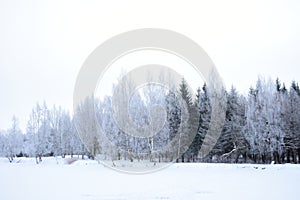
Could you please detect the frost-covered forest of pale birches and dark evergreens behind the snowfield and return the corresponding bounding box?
[0,77,300,163]
